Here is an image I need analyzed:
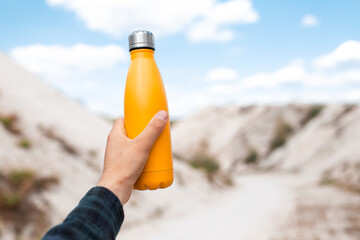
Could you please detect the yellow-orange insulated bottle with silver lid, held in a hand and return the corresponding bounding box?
[124,30,174,190]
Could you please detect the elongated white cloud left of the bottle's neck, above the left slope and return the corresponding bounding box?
[10,44,127,78]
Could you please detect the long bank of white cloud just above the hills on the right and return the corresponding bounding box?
[197,41,360,115]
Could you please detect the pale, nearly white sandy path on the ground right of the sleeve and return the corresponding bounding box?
[119,174,296,240]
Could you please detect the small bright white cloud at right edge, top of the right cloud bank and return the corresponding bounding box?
[313,40,360,68]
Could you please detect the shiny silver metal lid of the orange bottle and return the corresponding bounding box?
[129,30,155,51]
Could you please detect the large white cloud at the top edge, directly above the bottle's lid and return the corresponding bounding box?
[46,0,259,41]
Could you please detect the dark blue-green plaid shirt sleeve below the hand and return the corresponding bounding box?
[42,187,124,240]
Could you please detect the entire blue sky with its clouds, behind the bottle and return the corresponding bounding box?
[0,0,360,118]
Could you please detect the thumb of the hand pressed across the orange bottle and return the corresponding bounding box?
[136,110,169,151]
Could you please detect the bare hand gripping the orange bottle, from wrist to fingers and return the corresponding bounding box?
[97,110,168,205]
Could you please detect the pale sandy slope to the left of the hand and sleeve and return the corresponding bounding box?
[0,53,111,228]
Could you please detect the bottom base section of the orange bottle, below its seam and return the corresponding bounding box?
[134,169,174,190]
